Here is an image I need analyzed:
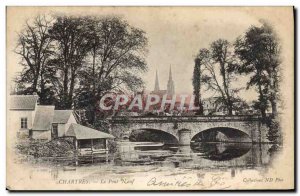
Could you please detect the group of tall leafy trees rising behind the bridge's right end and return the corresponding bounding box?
[193,21,281,117]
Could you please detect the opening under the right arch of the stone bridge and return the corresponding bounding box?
[191,127,251,142]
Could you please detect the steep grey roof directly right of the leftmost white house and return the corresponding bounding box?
[32,105,54,130]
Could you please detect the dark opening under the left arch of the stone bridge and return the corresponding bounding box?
[129,129,178,144]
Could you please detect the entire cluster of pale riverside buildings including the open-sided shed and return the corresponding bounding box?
[9,95,114,152]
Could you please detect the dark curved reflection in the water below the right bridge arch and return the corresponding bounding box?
[191,143,251,161]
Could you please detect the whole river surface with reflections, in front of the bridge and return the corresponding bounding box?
[17,142,276,179]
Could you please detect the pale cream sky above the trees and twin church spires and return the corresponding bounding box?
[7,7,292,101]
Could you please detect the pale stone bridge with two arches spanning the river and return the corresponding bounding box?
[110,115,268,145]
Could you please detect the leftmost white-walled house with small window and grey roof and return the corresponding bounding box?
[8,95,38,138]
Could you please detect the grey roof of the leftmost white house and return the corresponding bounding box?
[9,95,38,110]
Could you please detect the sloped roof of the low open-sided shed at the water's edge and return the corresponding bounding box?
[66,123,115,140]
